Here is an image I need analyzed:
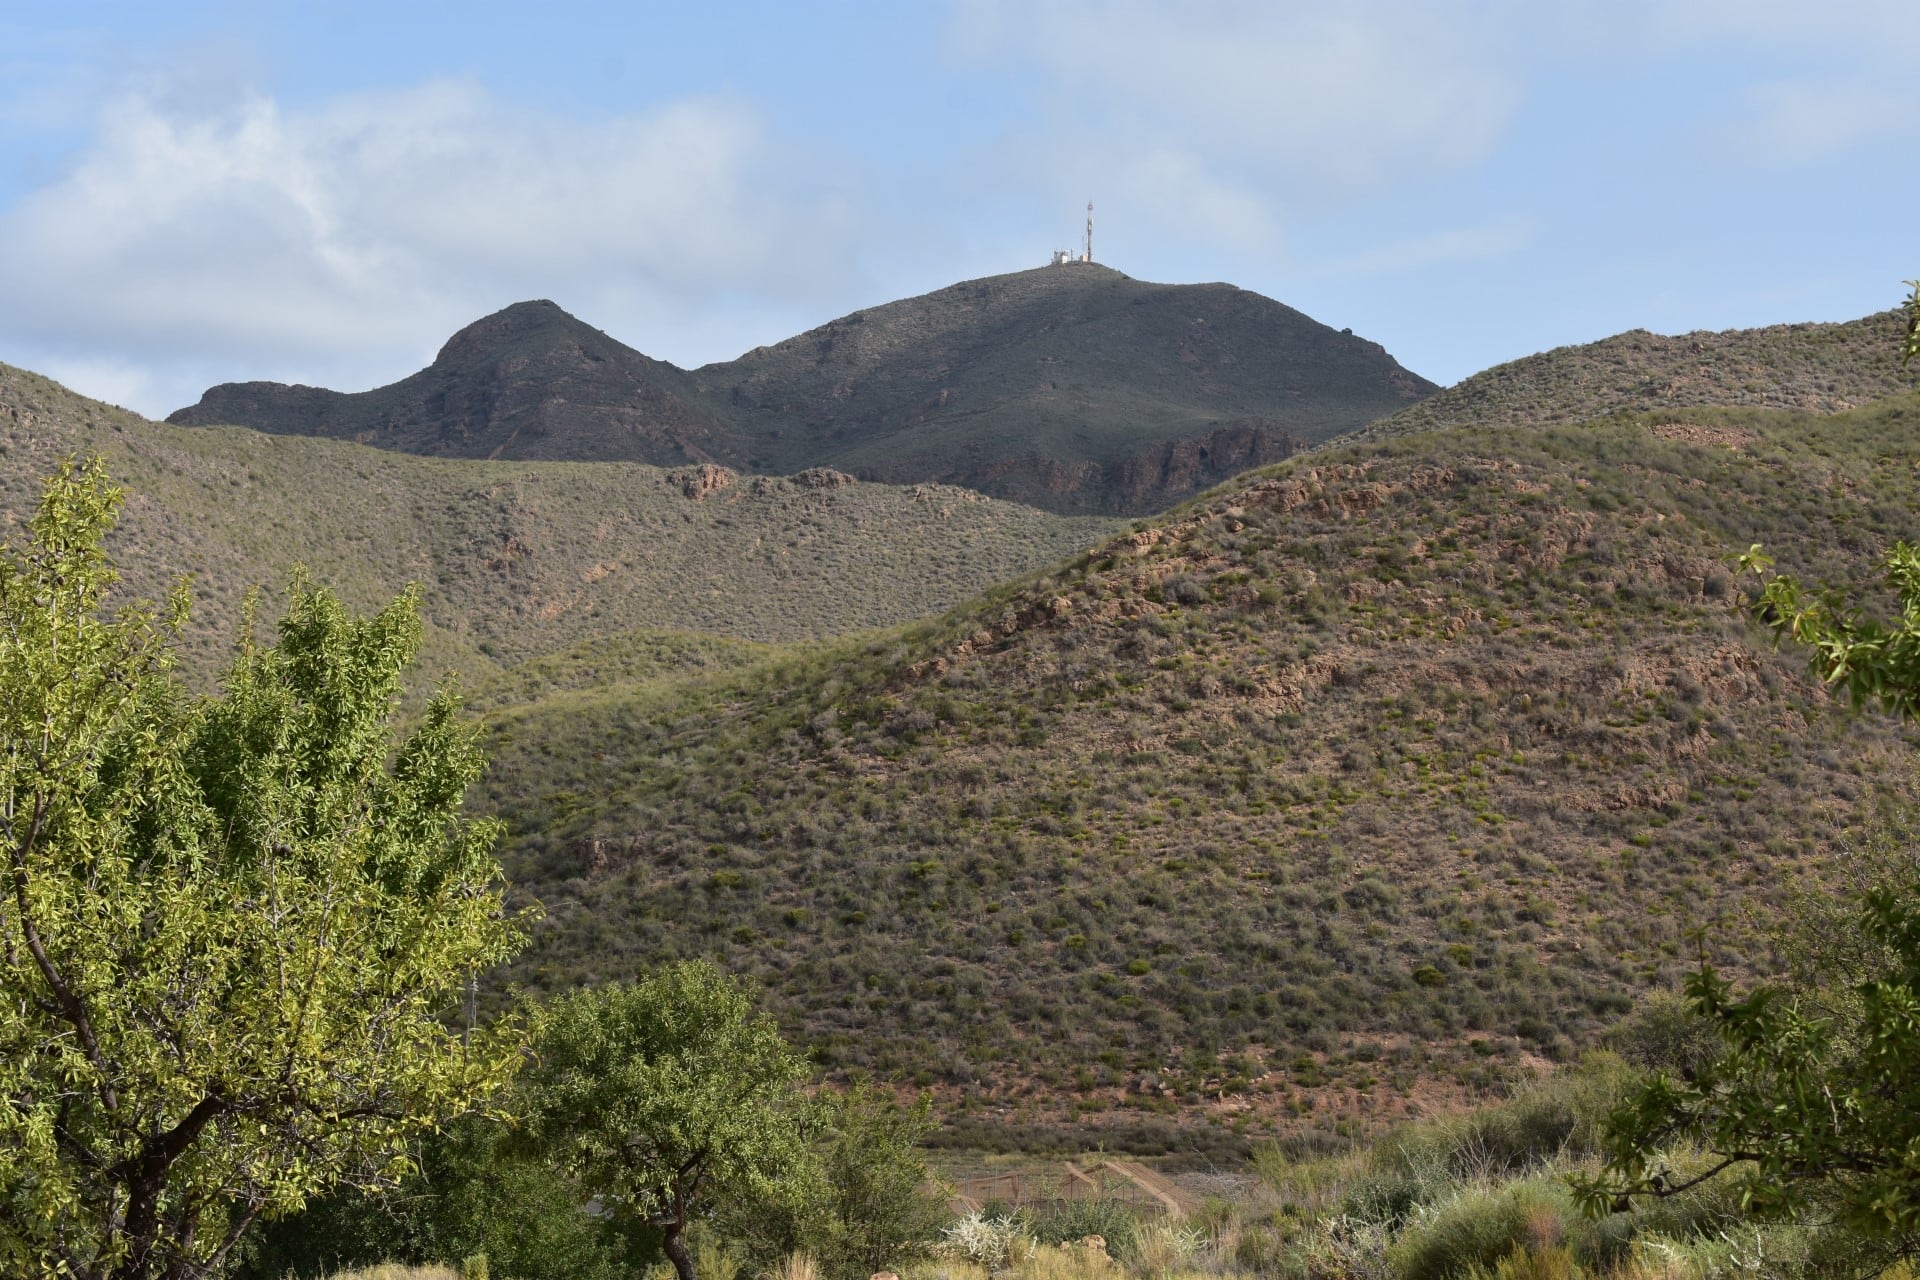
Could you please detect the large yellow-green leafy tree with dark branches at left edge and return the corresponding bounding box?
[0,462,522,1280]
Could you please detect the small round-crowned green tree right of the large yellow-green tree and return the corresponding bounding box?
[524,961,812,1280]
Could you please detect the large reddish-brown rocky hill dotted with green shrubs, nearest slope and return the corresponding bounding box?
[486,397,1920,1132]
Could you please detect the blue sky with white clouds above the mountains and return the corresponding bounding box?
[0,0,1920,416]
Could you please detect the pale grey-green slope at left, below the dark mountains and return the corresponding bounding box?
[0,365,1114,677]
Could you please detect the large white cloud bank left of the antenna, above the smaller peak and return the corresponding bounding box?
[0,83,856,411]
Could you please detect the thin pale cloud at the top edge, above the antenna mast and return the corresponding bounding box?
[954,0,1519,248]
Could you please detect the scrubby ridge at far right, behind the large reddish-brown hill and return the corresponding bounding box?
[1359,311,1914,439]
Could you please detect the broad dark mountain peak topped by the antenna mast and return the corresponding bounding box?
[693,265,1434,514]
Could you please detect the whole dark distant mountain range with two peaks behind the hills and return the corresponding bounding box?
[167,263,1434,514]
